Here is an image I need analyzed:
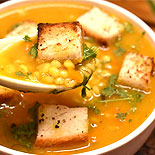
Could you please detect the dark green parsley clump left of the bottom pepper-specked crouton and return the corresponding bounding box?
[11,102,39,148]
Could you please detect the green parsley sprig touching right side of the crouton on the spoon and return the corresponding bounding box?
[82,43,98,60]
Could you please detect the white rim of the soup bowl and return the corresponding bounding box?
[0,0,155,155]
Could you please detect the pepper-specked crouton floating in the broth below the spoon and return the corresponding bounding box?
[35,105,88,148]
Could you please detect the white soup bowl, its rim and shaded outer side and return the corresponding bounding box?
[0,0,155,155]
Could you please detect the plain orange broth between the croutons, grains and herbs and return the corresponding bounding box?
[0,3,155,154]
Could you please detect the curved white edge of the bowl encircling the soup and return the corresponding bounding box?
[0,0,155,154]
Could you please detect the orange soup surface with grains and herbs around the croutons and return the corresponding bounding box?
[0,3,155,154]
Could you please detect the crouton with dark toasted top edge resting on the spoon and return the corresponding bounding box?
[38,22,83,63]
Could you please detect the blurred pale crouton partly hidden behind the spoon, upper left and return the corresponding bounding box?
[6,21,38,37]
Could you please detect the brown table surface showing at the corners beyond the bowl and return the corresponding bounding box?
[0,0,155,155]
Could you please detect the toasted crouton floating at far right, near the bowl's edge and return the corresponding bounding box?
[118,53,154,91]
